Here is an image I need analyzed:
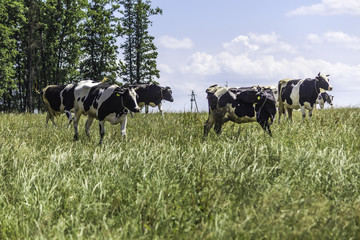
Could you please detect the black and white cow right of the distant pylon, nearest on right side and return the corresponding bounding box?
[204,85,276,137]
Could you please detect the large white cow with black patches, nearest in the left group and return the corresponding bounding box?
[74,80,140,144]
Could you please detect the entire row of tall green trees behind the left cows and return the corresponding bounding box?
[0,0,162,112]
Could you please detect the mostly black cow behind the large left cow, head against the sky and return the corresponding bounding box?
[125,83,174,115]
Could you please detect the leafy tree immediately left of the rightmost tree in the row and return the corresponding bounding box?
[80,0,118,82]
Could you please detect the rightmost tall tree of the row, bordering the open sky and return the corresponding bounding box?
[120,0,162,84]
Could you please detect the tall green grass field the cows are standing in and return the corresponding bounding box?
[0,108,360,239]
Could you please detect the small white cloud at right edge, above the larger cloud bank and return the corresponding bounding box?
[307,31,360,50]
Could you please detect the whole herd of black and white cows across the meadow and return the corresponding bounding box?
[35,73,333,144]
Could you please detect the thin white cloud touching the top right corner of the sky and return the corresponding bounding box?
[286,0,360,16]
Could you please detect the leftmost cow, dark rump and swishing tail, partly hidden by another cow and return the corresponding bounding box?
[35,84,75,126]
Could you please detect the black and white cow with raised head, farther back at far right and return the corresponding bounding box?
[278,73,333,123]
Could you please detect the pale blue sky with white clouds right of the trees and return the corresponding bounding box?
[146,0,360,111]
